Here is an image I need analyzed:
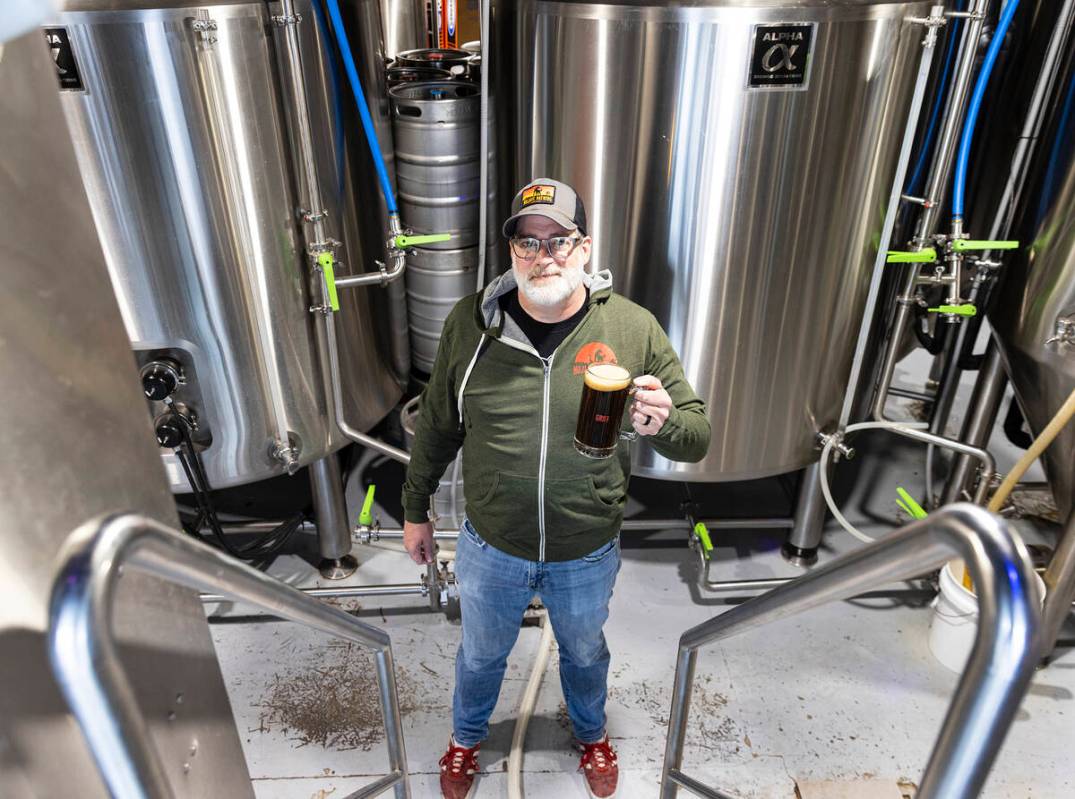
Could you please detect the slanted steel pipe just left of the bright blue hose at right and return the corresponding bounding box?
[868,0,988,428]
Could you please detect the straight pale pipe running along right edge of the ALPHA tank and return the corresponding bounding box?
[837,5,944,430]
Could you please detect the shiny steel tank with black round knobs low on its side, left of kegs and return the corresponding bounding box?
[54,0,406,490]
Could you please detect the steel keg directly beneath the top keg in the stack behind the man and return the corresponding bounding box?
[406,242,497,374]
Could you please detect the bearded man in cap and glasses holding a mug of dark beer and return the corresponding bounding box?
[403,177,710,799]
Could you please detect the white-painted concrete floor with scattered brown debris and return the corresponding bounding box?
[209,357,1075,799]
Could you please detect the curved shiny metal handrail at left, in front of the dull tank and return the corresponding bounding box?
[48,514,411,799]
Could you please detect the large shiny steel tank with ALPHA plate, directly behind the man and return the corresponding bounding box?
[497,0,928,481]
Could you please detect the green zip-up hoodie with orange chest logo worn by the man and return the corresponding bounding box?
[403,271,710,560]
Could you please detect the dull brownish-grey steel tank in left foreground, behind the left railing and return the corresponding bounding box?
[0,25,254,799]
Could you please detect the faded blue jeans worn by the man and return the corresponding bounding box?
[452,519,619,746]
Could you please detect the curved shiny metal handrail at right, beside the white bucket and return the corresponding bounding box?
[660,503,1041,799]
